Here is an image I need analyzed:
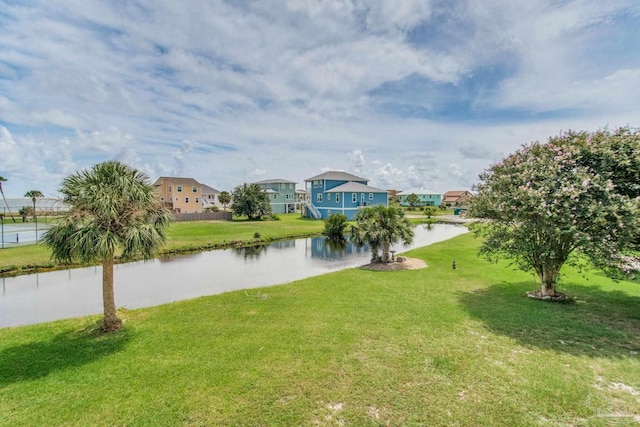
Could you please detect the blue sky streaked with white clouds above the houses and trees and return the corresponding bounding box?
[0,0,640,197]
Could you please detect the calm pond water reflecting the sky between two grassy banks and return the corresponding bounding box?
[0,224,468,327]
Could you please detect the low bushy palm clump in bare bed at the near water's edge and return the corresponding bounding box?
[350,205,413,262]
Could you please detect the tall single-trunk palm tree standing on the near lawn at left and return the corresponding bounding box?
[43,161,170,332]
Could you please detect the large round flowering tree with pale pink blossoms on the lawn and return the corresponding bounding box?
[470,128,640,298]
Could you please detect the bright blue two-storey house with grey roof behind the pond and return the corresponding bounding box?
[305,171,388,220]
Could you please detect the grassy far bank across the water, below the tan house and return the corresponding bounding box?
[0,214,324,277]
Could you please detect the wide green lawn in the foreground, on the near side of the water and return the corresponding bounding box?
[0,234,640,426]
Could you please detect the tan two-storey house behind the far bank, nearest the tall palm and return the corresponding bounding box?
[154,176,203,213]
